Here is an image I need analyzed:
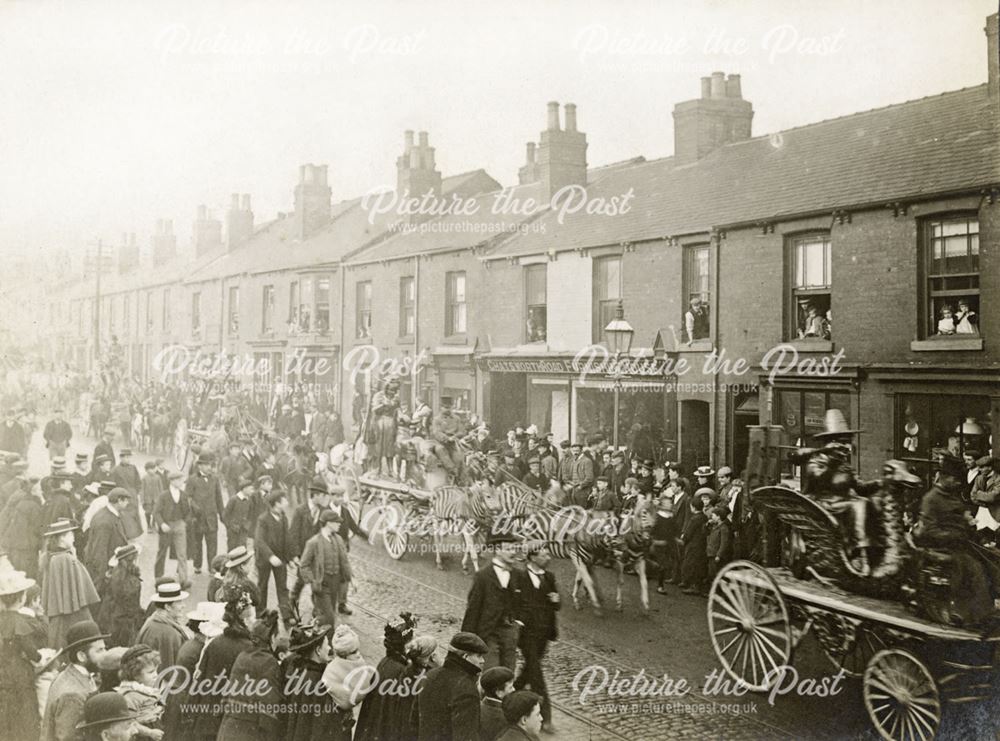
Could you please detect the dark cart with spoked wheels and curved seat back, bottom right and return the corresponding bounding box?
[708,487,1000,741]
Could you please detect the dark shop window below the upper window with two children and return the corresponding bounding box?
[894,394,990,459]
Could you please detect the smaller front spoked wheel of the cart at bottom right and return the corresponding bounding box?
[862,648,941,741]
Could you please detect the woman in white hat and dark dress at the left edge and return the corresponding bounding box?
[0,568,45,741]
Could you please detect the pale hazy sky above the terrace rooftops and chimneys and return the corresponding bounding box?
[0,0,997,258]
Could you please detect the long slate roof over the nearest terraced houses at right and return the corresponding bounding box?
[487,85,1000,259]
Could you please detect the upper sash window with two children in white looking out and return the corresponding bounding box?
[923,217,980,338]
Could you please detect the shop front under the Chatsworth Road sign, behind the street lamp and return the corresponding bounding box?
[480,354,677,460]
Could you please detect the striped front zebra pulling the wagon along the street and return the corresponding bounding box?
[521,503,652,614]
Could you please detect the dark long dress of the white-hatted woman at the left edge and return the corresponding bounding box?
[0,610,45,741]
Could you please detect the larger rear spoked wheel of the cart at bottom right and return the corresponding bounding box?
[708,561,794,692]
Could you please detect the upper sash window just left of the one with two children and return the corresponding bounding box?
[787,234,833,340]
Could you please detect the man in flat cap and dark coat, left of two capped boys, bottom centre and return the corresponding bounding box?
[417,631,488,741]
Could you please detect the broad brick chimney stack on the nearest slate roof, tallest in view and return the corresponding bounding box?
[674,72,753,164]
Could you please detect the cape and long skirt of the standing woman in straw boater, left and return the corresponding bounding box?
[41,549,101,649]
